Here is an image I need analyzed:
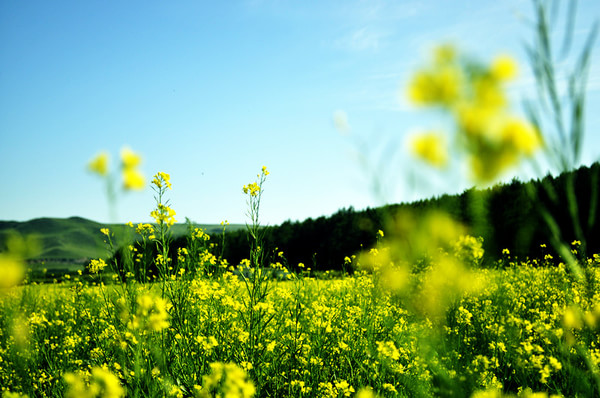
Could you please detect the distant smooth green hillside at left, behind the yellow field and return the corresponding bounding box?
[0,217,243,269]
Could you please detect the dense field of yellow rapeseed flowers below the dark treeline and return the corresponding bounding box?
[0,238,600,397]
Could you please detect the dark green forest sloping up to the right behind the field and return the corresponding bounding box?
[213,162,600,271]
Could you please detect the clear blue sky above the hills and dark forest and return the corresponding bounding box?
[0,0,600,224]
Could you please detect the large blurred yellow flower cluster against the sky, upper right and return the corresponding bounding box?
[408,45,542,182]
